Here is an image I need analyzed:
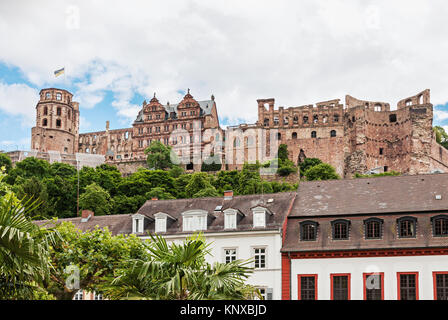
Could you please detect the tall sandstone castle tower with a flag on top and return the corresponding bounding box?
[31,88,79,154]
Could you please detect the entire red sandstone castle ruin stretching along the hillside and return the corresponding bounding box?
[31,88,448,178]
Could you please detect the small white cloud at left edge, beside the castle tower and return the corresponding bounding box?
[0,81,39,126]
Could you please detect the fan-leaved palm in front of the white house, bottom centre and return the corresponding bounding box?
[103,235,259,300]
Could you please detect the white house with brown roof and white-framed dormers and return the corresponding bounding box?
[132,191,295,300]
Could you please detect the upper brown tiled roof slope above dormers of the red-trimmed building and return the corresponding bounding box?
[290,174,448,217]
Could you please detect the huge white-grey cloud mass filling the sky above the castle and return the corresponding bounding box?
[0,0,448,126]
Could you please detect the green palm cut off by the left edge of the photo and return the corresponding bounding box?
[0,170,55,299]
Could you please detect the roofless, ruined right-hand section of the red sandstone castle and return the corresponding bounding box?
[230,89,448,177]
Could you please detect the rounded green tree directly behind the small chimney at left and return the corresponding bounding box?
[79,183,112,216]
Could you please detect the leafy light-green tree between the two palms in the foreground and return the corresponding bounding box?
[45,220,149,300]
